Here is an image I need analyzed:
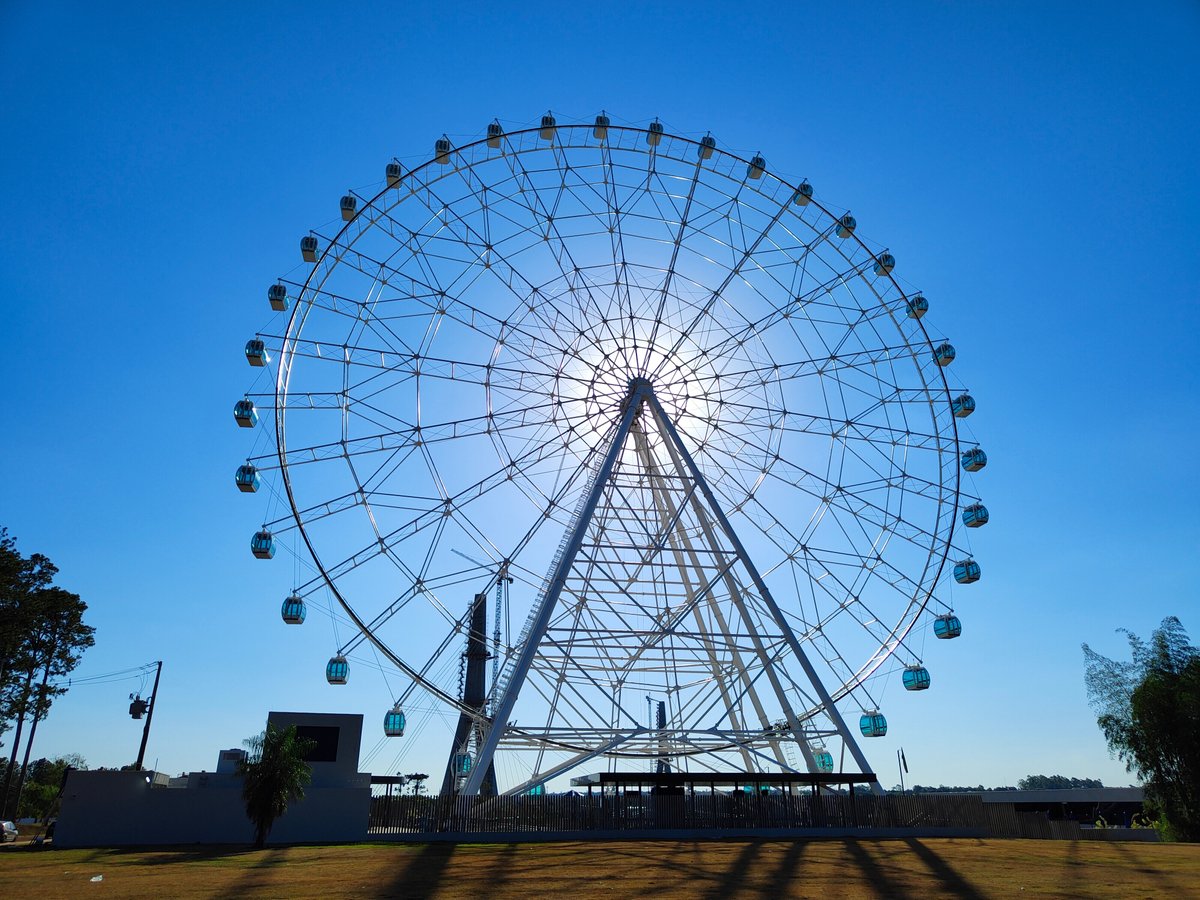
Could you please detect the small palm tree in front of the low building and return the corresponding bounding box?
[238,724,317,850]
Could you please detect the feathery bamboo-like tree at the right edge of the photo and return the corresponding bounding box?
[1084,616,1200,841]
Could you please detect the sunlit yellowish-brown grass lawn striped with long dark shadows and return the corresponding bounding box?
[0,839,1200,900]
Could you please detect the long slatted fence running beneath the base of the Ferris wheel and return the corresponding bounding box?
[368,791,986,836]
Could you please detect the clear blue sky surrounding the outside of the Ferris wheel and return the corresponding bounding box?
[0,0,1200,785]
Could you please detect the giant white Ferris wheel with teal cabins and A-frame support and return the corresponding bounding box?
[235,115,988,793]
